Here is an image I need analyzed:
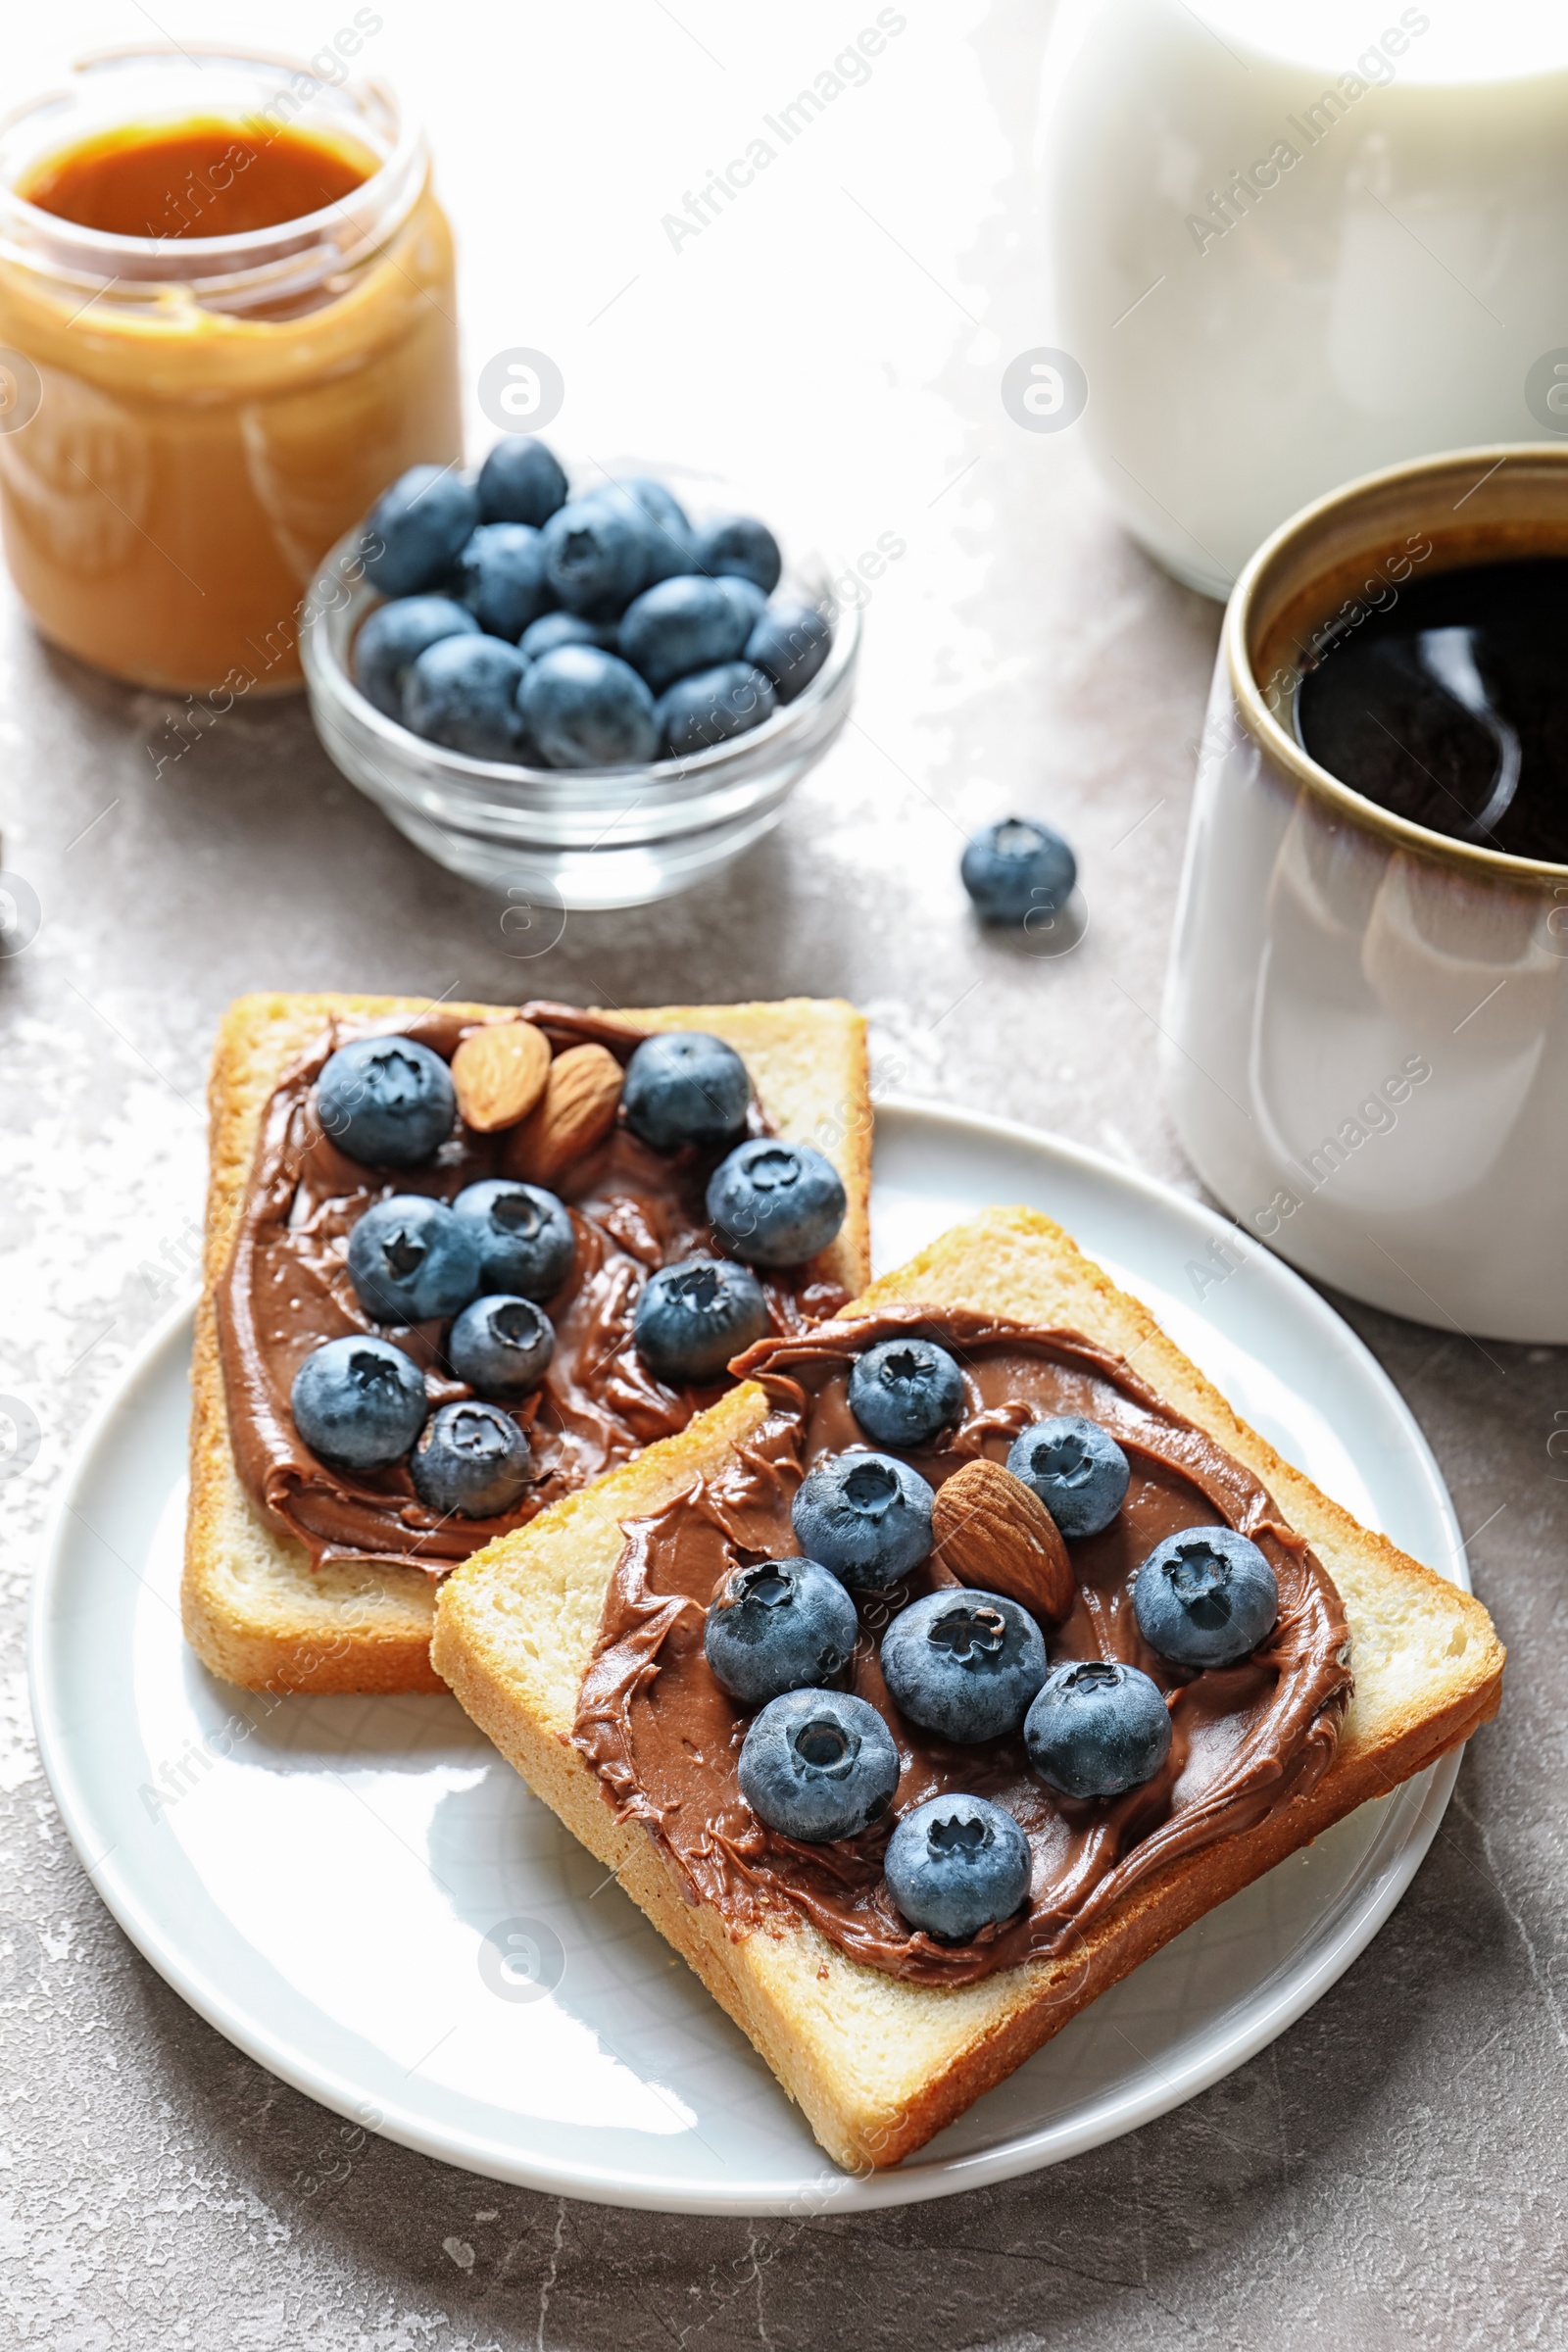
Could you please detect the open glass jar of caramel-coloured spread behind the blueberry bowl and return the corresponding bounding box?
[0,45,461,706]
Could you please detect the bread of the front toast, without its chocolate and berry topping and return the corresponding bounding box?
[432,1209,1502,2171]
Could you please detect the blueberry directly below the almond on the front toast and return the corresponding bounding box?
[882,1586,1046,1742]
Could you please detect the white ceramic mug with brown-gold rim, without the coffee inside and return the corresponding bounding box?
[1163,445,1568,1343]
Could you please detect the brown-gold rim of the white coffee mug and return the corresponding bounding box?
[1222,442,1568,884]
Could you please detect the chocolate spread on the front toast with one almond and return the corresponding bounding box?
[573,1307,1351,1985]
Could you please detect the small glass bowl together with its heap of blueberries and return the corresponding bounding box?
[301,435,858,907]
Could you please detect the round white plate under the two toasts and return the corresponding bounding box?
[33,1103,1464,2213]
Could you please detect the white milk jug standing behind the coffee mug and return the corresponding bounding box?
[1039,0,1568,598]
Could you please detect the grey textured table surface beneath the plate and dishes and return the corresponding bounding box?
[0,5,1568,2352]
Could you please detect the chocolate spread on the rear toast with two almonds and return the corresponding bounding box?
[217,1004,844,1576]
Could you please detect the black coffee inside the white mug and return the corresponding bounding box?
[1296,555,1568,863]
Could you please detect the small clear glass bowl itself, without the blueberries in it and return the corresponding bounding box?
[301,466,860,912]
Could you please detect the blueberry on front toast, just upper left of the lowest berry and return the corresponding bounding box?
[738,1691,898,1844]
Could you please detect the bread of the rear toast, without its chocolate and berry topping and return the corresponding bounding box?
[181,995,872,1691]
